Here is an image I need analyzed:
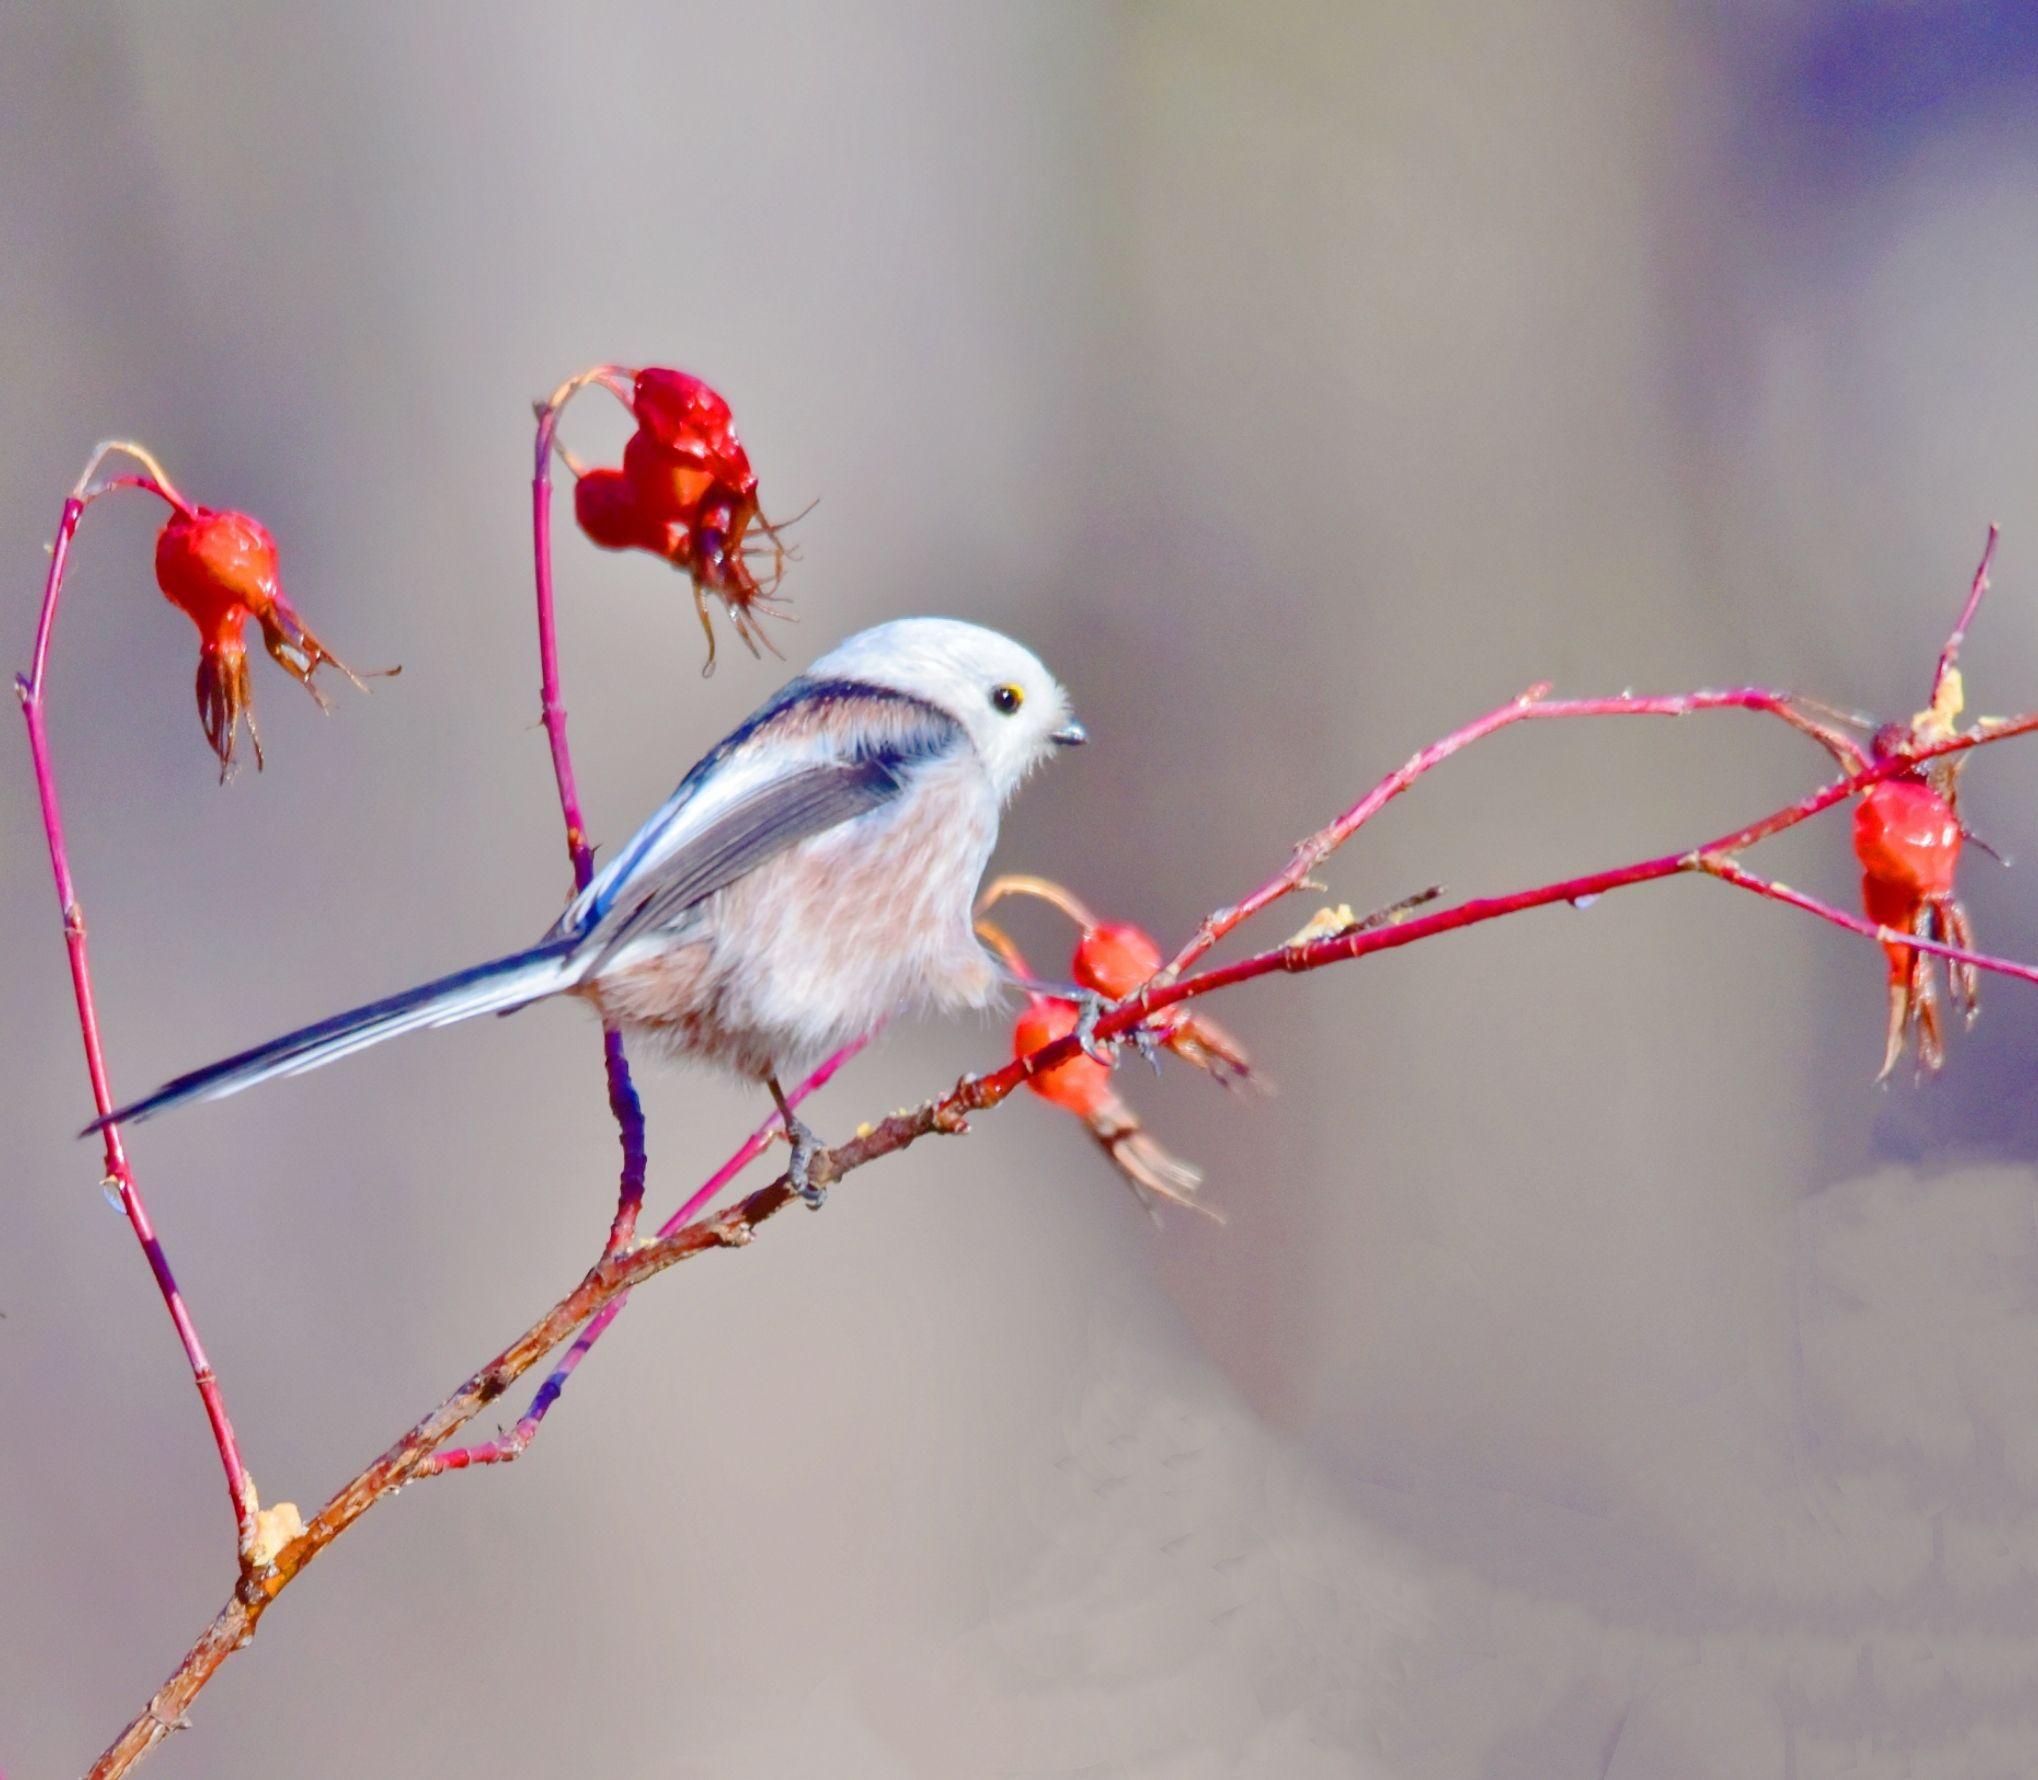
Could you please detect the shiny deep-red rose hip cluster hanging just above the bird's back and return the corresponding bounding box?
[573,365,791,673]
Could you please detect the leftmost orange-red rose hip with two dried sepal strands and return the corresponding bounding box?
[155,508,365,781]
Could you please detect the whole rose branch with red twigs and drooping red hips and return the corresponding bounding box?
[18,365,2038,1776]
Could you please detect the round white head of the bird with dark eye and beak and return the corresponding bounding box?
[807,618,1084,801]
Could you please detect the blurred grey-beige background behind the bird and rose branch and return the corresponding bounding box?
[0,0,2038,1780]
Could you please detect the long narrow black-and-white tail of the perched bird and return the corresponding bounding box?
[82,938,579,1136]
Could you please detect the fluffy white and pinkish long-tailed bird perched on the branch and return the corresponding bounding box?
[92,618,1084,1203]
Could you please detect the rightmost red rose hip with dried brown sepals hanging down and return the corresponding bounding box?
[1855,777,1981,1081]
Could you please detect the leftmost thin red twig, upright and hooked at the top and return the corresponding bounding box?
[14,442,257,1566]
